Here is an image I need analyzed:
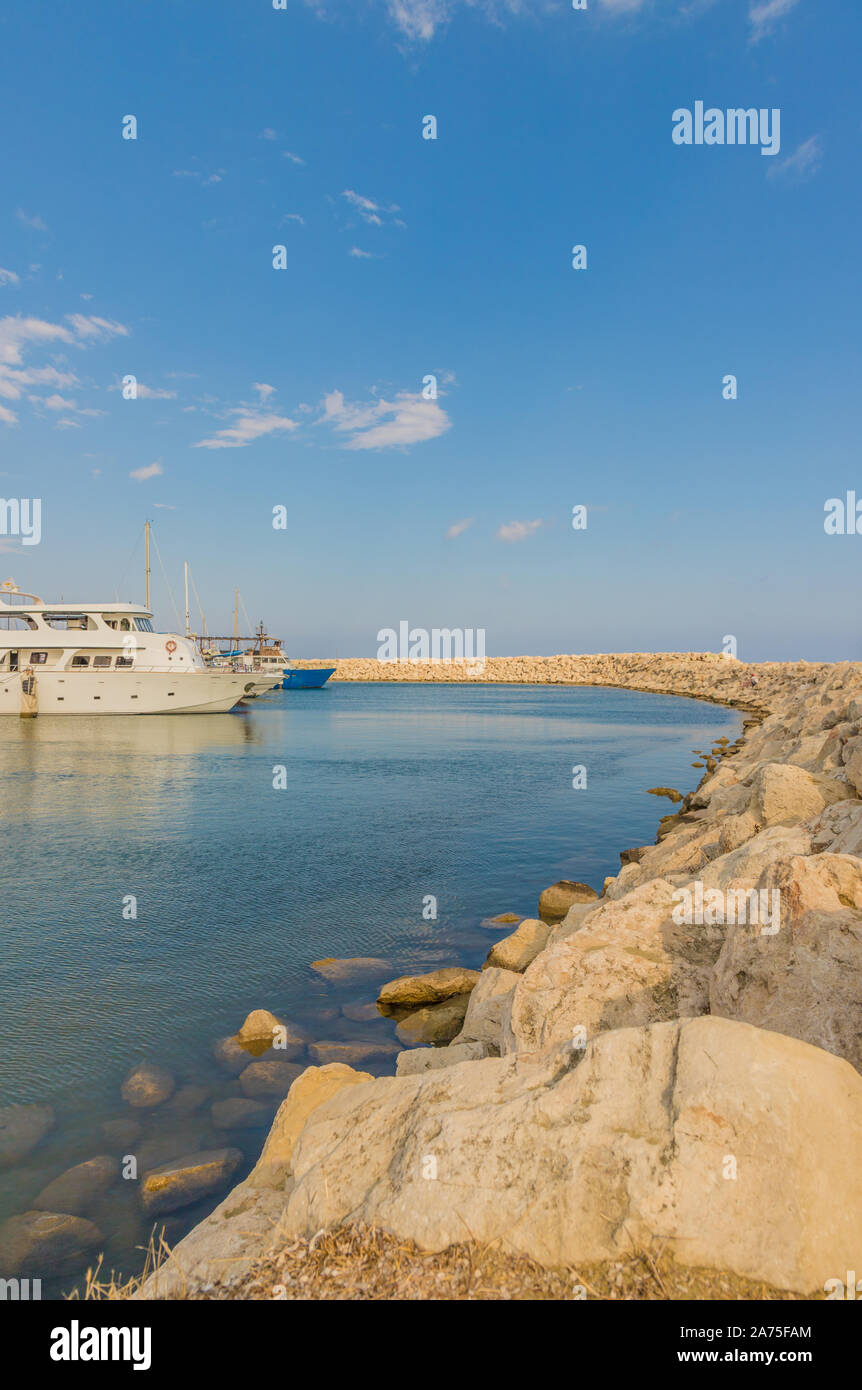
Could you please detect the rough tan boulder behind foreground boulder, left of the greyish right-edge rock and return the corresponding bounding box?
[505,878,722,1052]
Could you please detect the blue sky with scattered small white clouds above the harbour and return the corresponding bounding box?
[0,0,862,660]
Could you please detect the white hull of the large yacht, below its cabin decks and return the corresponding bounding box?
[0,670,250,714]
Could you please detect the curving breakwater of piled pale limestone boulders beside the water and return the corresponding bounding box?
[142,656,862,1297]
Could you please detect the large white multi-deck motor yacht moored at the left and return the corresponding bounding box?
[0,581,253,717]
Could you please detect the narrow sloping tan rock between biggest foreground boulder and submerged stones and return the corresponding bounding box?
[135,1063,371,1298]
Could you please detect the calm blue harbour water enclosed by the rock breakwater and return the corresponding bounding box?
[0,684,740,1291]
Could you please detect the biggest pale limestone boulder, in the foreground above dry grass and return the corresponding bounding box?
[284,1017,862,1294]
